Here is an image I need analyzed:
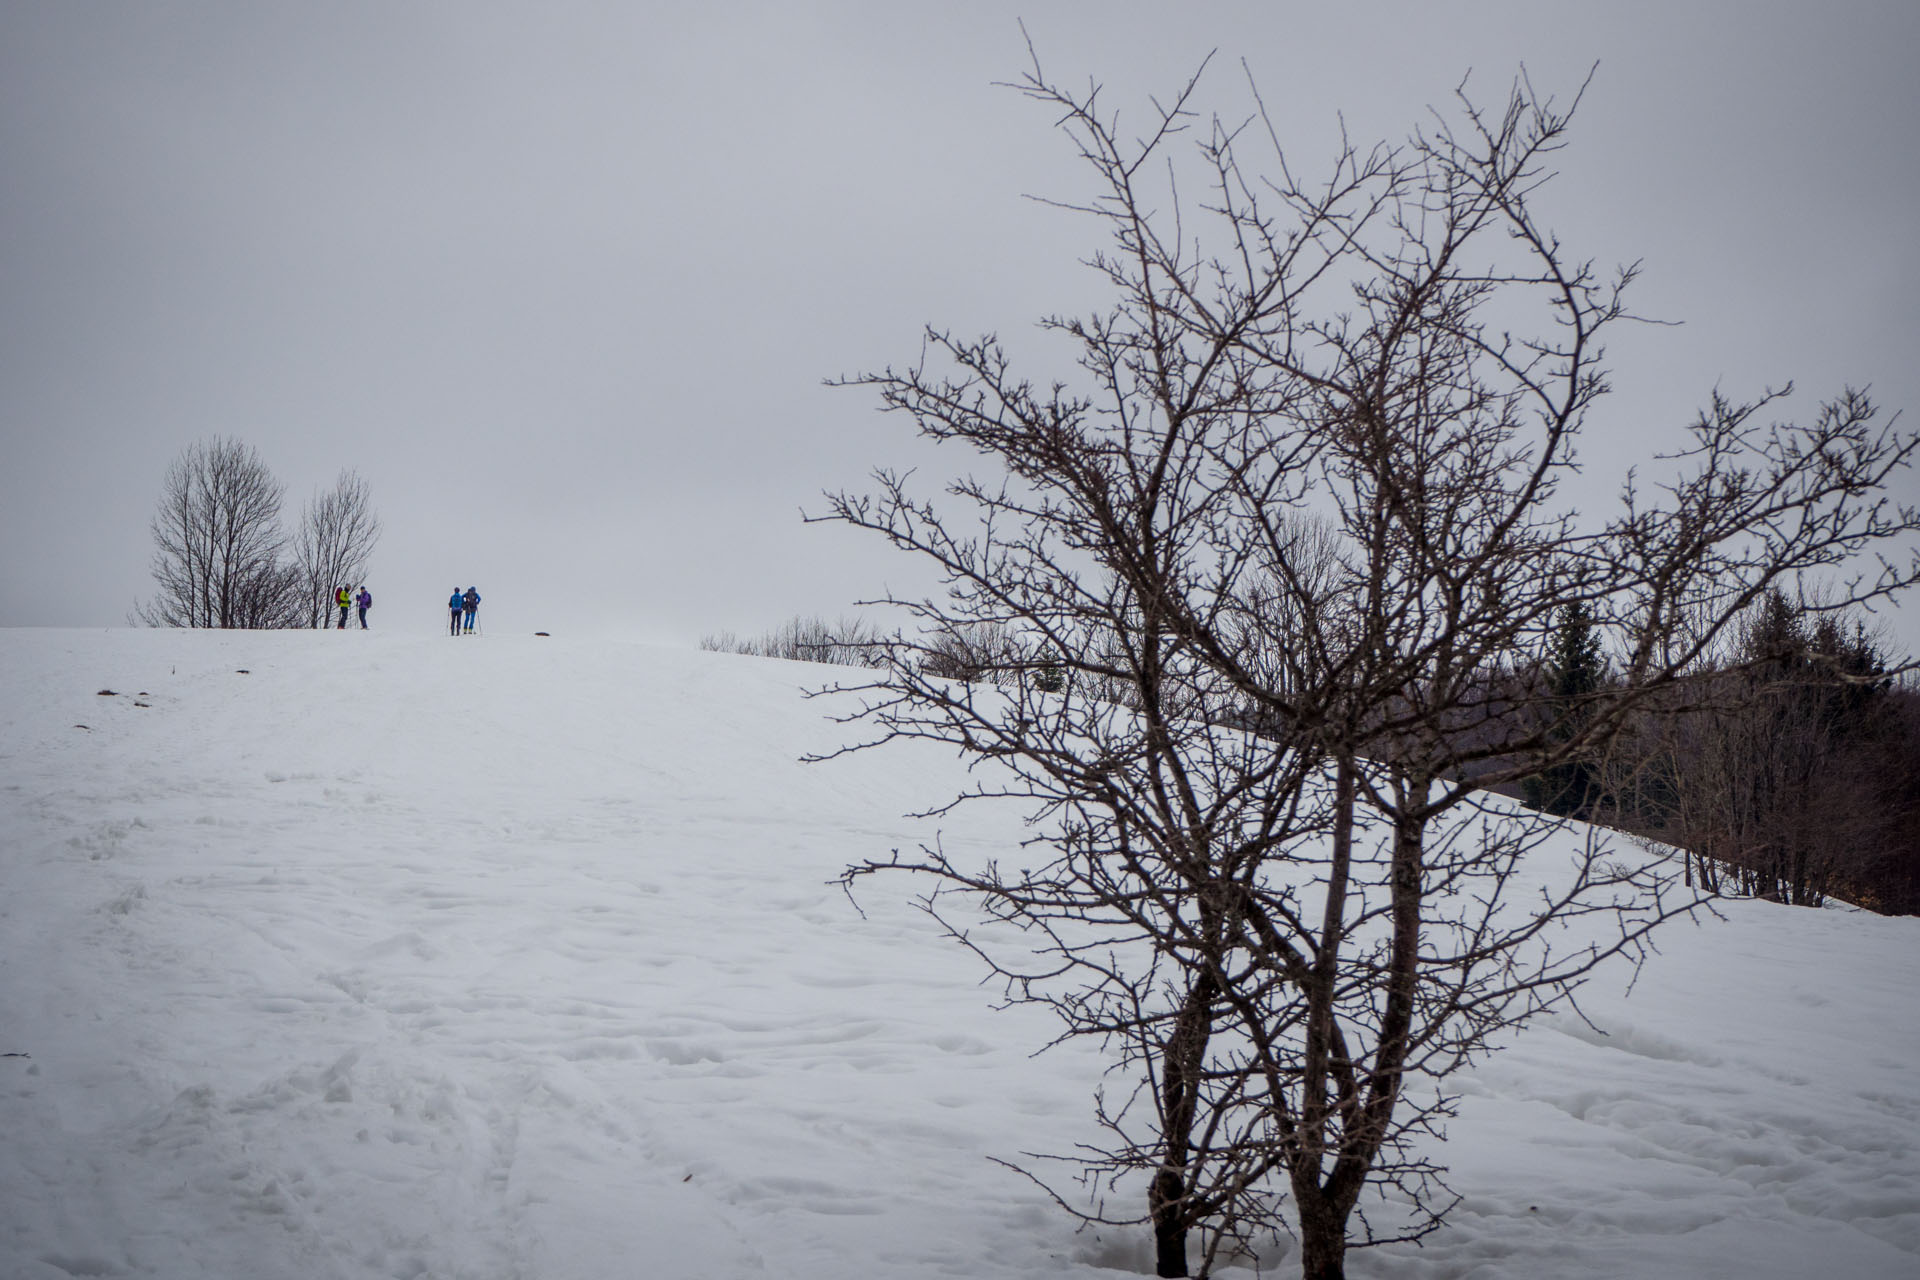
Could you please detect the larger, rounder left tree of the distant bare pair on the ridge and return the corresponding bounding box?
[134,438,300,628]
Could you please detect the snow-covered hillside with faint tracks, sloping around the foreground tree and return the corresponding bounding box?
[0,631,1920,1280]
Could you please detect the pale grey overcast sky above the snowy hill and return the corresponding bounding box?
[0,0,1920,647]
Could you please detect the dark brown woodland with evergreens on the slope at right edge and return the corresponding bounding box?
[1526,591,1920,915]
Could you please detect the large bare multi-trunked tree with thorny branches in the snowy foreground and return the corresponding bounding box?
[826,52,1920,1280]
